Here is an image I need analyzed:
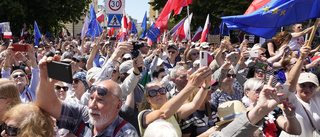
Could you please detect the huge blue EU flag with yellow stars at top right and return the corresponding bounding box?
[221,0,320,38]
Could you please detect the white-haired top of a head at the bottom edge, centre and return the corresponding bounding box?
[144,119,179,137]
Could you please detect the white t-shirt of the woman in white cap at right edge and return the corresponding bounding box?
[280,91,320,137]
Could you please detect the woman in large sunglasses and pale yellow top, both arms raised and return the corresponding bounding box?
[138,67,212,136]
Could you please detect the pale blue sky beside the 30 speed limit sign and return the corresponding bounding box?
[98,0,150,23]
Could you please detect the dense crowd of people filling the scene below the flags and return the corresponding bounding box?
[0,23,320,137]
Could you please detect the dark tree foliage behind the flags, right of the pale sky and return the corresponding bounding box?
[149,0,252,31]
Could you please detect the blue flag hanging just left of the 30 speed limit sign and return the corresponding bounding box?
[86,4,102,40]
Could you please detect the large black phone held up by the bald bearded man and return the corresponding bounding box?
[47,61,73,84]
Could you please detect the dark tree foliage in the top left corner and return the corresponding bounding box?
[0,0,91,35]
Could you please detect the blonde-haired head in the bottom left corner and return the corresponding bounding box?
[1,103,53,137]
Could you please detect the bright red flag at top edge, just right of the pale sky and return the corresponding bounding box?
[154,0,174,29]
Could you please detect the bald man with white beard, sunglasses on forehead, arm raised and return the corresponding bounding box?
[37,57,137,137]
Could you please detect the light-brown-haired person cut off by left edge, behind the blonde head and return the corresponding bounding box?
[0,78,21,133]
